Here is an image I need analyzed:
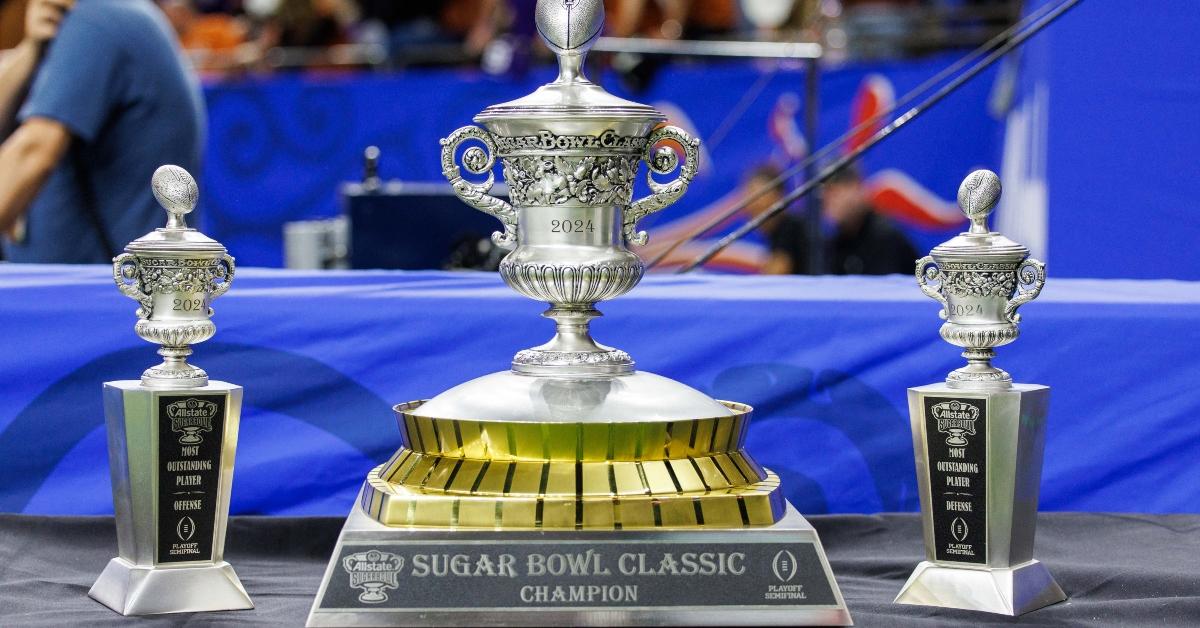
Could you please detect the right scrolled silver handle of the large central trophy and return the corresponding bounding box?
[625,126,700,245]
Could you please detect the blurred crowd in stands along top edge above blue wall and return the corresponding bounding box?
[0,0,1021,76]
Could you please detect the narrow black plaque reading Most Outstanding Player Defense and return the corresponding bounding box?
[925,397,988,564]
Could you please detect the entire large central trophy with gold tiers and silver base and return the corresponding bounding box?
[308,0,850,626]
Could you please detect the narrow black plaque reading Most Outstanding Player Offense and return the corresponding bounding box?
[157,395,228,563]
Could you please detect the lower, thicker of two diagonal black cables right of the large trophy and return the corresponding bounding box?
[678,0,1081,274]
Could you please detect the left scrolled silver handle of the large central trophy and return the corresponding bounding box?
[442,126,517,249]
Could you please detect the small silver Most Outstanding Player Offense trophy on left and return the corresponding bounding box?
[88,166,254,615]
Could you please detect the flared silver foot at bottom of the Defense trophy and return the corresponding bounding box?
[895,561,1067,617]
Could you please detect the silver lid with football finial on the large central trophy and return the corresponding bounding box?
[475,0,666,124]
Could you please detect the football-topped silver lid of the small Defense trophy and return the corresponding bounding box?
[930,171,1030,263]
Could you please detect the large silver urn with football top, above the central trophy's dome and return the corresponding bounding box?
[442,0,700,375]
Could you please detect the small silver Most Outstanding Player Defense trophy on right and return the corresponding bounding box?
[896,171,1066,615]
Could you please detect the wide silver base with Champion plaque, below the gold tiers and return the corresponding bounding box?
[307,506,852,627]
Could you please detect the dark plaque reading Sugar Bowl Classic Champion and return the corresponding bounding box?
[317,538,838,611]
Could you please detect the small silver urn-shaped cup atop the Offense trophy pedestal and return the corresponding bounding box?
[113,166,235,388]
